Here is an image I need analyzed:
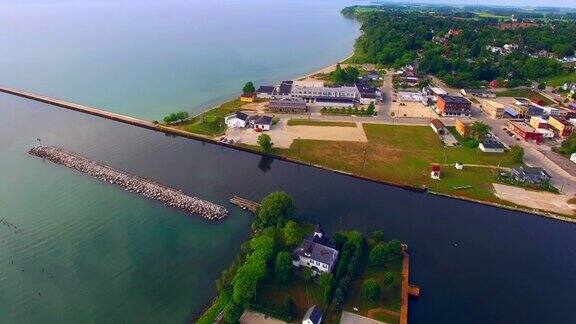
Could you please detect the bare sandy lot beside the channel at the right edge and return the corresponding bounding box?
[493,183,576,215]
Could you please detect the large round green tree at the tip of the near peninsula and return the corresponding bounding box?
[253,191,296,228]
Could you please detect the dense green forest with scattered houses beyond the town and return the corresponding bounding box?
[342,7,576,87]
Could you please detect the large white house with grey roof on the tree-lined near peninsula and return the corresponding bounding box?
[292,226,338,276]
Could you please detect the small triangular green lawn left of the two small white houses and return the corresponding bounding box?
[169,99,248,136]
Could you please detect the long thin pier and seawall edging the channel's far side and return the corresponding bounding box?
[0,87,576,223]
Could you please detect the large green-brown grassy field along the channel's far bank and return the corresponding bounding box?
[275,124,514,202]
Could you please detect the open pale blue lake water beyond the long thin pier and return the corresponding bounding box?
[0,0,359,119]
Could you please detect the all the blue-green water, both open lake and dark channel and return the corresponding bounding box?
[0,1,576,323]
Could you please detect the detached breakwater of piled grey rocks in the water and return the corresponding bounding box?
[28,145,228,220]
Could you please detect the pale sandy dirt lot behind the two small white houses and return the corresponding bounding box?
[226,119,368,148]
